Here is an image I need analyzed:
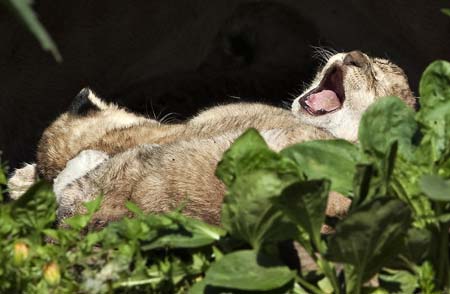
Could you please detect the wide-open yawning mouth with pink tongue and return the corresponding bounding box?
[299,65,345,116]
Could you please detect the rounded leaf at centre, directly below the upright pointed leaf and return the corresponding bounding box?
[222,171,296,248]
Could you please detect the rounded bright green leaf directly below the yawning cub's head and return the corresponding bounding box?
[358,97,416,158]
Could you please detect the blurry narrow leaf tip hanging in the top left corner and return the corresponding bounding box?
[4,0,62,62]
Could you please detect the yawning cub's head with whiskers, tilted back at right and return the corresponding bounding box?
[292,51,416,141]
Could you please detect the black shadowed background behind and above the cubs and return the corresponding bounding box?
[0,0,450,167]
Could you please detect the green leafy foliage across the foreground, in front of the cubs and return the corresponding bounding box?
[0,61,450,293]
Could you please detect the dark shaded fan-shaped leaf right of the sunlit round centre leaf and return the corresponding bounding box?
[277,180,330,253]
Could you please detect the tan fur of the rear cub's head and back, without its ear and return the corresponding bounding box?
[37,96,329,181]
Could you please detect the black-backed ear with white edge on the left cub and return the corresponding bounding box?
[69,87,108,116]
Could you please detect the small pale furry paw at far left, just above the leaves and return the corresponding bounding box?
[8,163,38,200]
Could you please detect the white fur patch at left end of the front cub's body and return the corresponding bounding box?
[53,150,109,203]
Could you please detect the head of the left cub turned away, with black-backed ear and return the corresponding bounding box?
[37,88,153,180]
